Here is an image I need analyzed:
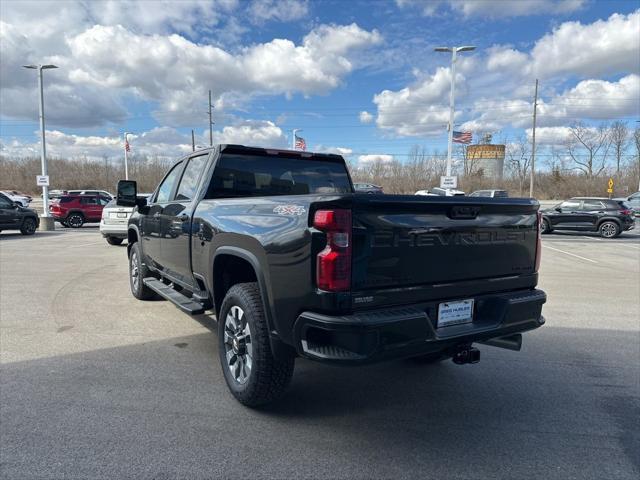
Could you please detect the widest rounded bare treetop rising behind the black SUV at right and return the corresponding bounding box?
[565,122,611,179]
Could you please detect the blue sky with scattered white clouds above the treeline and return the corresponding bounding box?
[0,0,640,165]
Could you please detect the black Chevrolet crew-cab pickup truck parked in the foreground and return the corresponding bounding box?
[117,145,546,406]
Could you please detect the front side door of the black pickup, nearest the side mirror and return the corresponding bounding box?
[140,162,184,269]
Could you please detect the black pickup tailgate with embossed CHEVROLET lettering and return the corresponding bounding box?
[352,195,539,291]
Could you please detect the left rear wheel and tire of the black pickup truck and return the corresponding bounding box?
[218,283,295,407]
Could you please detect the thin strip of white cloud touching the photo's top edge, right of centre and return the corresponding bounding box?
[396,0,586,18]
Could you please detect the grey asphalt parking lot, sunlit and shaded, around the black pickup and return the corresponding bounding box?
[0,227,640,479]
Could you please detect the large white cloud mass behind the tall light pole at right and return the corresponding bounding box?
[373,10,640,136]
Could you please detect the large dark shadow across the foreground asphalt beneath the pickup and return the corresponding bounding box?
[0,327,640,478]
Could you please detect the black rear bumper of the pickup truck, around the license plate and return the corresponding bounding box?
[294,290,547,364]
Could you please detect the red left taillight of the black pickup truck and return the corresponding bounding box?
[313,209,351,292]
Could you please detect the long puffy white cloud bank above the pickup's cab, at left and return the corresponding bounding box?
[0,20,381,126]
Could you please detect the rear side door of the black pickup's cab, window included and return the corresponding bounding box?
[160,153,209,286]
